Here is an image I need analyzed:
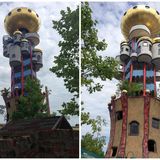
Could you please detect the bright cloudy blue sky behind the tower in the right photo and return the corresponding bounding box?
[82,2,160,151]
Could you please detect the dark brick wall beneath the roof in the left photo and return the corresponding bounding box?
[0,129,79,158]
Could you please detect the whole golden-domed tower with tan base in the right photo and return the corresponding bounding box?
[106,5,160,158]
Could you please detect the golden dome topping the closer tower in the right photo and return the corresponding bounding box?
[121,5,160,40]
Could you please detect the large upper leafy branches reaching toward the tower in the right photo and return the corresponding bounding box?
[81,2,117,93]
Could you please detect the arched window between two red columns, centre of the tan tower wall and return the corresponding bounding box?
[129,121,139,136]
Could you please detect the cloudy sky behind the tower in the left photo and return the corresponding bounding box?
[0,2,79,125]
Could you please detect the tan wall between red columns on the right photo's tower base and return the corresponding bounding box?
[106,96,160,158]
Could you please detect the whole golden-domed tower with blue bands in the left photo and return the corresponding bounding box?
[2,7,43,120]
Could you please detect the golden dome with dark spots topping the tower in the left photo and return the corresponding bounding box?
[4,7,40,35]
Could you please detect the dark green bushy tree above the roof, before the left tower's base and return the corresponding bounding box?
[12,77,47,120]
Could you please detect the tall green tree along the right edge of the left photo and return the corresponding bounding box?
[50,7,79,115]
